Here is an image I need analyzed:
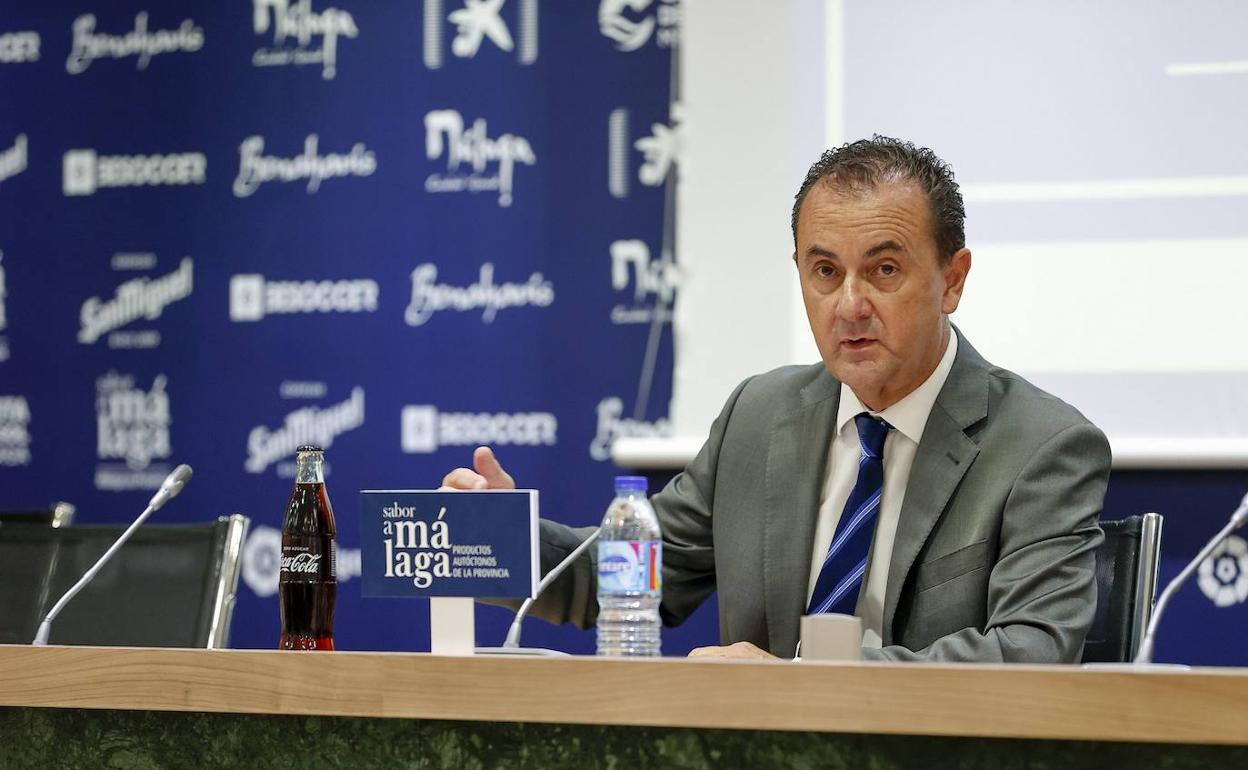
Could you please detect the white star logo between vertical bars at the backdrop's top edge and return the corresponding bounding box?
[424,0,538,70]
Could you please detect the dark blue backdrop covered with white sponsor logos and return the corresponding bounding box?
[0,0,688,653]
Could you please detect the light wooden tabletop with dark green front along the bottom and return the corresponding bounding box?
[0,645,1248,768]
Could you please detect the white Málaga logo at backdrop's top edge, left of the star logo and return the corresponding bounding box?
[251,0,359,80]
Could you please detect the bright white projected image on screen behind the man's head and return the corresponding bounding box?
[828,0,1248,467]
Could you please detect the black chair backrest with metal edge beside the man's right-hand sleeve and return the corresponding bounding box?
[1083,513,1162,663]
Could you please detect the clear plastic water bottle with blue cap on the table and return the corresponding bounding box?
[598,475,663,656]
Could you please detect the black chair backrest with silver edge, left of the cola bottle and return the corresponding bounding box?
[0,514,248,648]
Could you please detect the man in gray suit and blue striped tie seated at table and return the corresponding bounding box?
[443,136,1109,663]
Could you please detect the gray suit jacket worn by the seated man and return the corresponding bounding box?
[534,329,1109,663]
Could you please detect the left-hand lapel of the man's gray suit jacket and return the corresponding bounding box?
[763,372,840,655]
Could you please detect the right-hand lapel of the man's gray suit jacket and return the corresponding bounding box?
[882,332,988,645]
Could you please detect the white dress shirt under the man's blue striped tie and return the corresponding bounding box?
[806,329,957,648]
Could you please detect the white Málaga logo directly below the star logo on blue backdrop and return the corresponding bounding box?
[424,110,538,206]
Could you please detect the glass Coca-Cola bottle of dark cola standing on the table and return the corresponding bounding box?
[277,447,338,650]
